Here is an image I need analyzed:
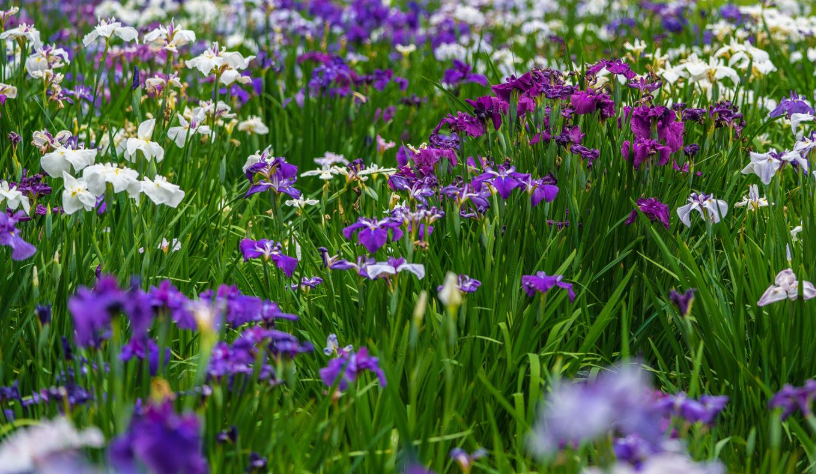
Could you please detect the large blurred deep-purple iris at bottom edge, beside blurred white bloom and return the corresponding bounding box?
[109,400,207,474]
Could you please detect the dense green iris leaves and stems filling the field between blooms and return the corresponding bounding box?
[0,1,816,473]
